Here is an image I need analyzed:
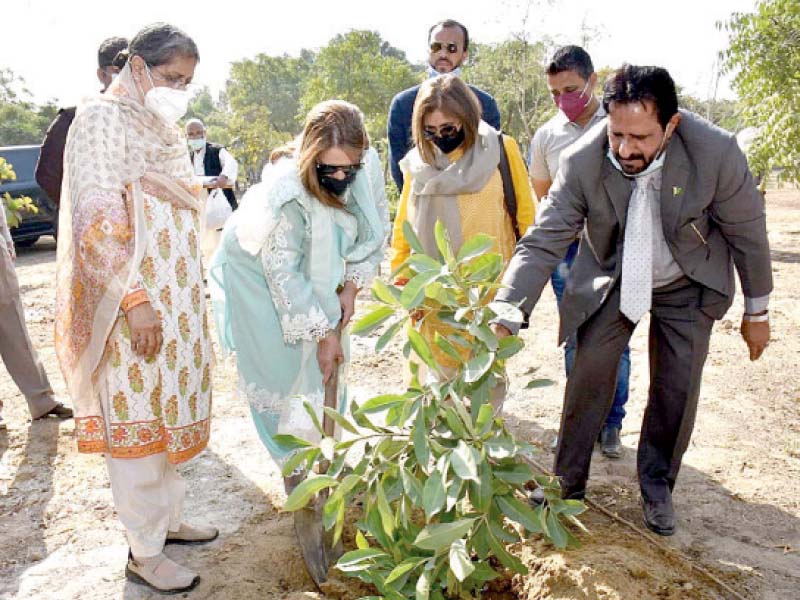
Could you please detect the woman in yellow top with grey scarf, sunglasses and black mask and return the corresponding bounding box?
[391,74,534,408]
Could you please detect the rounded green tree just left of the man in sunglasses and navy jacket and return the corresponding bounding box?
[301,30,419,139]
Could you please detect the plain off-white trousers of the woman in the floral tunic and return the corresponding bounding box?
[106,452,186,558]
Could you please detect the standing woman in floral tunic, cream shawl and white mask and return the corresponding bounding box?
[55,23,217,592]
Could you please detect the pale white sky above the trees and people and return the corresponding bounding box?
[0,0,756,106]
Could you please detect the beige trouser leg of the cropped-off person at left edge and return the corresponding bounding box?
[0,241,58,419]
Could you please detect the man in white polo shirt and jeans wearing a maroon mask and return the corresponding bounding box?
[530,46,631,458]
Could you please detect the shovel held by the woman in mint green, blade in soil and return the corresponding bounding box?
[294,327,344,588]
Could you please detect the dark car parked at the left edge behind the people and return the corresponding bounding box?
[0,146,58,246]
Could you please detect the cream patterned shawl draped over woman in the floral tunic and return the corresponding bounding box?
[55,65,201,438]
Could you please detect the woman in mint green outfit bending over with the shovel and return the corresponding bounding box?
[210,101,389,478]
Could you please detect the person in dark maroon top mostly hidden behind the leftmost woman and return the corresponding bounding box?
[36,37,128,206]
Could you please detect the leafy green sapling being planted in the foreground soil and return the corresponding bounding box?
[279,222,584,600]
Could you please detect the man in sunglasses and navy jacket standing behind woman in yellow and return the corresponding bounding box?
[388,19,500,192]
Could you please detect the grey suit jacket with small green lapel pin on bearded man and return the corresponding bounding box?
[497,110,772,341]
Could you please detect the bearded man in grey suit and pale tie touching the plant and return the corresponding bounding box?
[495,65,772,535]
